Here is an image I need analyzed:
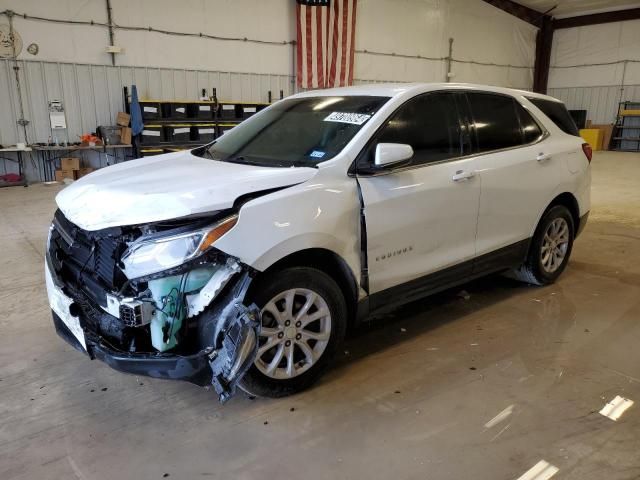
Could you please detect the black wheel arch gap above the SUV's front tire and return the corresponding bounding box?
[250,248,358,324]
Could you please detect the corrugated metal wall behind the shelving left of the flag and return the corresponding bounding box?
[0,60,293,145]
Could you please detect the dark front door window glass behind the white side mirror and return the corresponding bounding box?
[372,93,461,165]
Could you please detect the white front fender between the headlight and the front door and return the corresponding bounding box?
[215,169,360,278]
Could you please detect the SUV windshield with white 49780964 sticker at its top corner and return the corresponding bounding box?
[205,96,389,167]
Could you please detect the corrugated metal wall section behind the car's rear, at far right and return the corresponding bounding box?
[548,85,640,123]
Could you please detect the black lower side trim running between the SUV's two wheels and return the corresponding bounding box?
[358,238,531,318]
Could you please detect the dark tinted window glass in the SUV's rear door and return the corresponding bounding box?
[467,93,528,152]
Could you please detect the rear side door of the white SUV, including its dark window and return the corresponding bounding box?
[467,92,567,261]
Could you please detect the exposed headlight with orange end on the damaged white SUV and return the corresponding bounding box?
[122,214,238,279]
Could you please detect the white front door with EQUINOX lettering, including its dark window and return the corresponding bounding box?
[357,92,480,299]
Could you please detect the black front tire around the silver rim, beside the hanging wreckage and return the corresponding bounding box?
[239,267,347,398]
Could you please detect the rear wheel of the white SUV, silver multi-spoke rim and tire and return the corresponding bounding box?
[513,205,575,285]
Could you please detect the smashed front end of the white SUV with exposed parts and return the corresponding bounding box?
[46,211,260,402]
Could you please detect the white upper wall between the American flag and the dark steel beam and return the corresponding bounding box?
[355,0,537,88]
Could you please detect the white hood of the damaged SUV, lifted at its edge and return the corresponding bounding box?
[56,151,317,230]
